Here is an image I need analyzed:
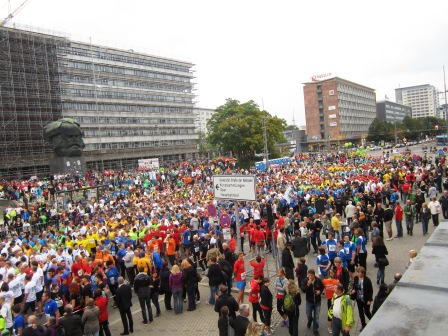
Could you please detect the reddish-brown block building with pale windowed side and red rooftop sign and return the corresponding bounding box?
[303,77,376,149]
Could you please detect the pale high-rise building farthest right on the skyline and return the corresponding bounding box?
[395,84,439,118]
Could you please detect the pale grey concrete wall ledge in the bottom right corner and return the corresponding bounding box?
[355,221,448,336]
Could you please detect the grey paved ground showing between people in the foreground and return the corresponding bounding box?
[104,215,434,336]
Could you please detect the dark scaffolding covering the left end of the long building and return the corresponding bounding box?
[0,28,67,177]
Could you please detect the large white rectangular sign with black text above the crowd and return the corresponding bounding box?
[213,175,257,201]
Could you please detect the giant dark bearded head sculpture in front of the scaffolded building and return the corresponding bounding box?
[44,118,85,157]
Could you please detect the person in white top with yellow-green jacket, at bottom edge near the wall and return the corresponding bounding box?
[328,283,355,336]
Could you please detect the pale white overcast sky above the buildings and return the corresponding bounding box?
[0,0,448,125]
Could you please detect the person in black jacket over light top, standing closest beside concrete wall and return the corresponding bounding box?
[351,266,373,331]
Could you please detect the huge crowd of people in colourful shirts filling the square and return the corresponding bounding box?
[0,148,448,336]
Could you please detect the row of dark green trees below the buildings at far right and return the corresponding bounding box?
[367,116,446,142]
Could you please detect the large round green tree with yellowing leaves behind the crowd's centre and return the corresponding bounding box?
[207,99,286,159]
